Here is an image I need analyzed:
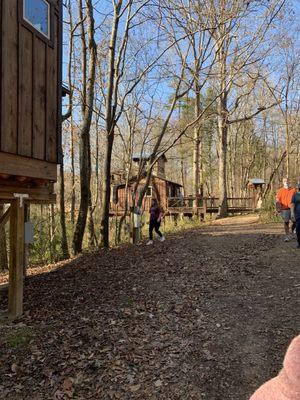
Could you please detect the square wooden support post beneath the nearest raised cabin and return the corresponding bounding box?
[8,199,24,318]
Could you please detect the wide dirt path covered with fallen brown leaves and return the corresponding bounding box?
[0,217,300,400]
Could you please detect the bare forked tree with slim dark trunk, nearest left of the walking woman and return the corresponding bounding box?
[101,0,197,247]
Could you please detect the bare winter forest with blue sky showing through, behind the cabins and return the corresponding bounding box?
[0,0,300,269]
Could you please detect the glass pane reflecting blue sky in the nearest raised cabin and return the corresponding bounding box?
[23,0,50,39]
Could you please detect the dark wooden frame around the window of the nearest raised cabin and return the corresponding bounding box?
[19,0,54,47]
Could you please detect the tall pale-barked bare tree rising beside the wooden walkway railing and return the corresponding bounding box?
[204,0,285,216]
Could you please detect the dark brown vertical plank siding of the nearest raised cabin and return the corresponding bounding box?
[0,0,62,180]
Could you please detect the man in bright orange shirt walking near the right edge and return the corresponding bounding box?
[276,178,296,242]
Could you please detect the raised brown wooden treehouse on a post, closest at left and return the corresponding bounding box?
[0,0,63,316]
